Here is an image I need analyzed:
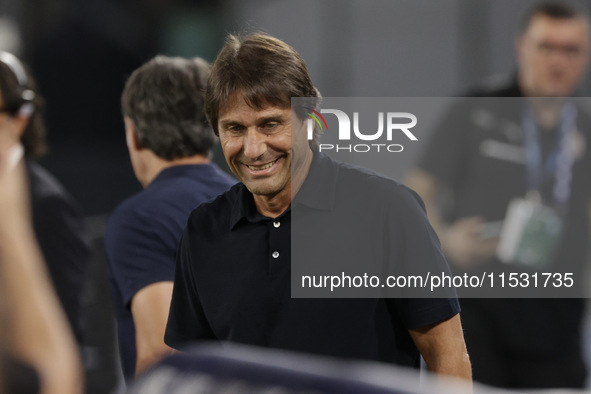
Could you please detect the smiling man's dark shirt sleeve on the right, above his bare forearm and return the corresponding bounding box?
[388,185,460,328]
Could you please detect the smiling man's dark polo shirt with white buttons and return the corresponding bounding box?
[165,154,459,366]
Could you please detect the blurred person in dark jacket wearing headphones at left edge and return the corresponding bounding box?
[0,51,90,343]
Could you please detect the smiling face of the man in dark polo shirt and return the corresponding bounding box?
[218,92,311,198]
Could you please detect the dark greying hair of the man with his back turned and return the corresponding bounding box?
[121,56,215,160]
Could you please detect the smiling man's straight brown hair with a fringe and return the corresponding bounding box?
[205,33,321,140]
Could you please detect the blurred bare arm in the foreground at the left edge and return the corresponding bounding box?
[0,114,83,394]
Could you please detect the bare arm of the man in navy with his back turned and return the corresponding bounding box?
[131,281,173,375]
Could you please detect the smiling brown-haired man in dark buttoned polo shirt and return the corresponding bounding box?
[165,34,471,379]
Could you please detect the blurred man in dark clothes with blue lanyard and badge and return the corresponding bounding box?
[406,2,591,388]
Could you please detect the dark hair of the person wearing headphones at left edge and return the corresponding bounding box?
[0,62,47,159]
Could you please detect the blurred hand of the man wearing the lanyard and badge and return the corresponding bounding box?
[439,216,499,269]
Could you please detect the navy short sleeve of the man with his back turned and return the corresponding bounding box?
[105,209,178,308]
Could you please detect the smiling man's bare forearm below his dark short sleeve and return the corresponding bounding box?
[408,314,472,381]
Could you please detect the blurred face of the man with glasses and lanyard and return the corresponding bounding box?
[517,15,589,97]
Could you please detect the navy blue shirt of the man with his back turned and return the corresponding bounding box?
[105,164,236,378]
